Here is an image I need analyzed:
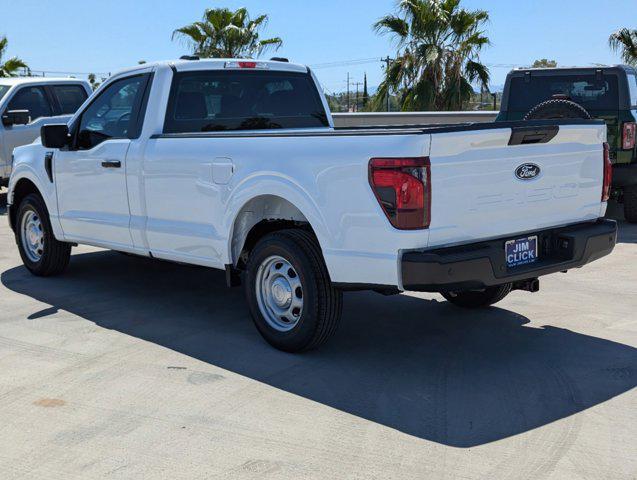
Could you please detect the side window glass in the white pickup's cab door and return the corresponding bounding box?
[77,75,148,150]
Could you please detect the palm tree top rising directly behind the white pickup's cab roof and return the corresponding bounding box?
[173,8,283,58]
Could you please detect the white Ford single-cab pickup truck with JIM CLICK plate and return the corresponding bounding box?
[8,59,617,352]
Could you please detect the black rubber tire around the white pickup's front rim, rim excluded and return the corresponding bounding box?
[15,193,71,277]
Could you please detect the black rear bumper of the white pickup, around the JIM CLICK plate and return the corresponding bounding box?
[401,219,617,292]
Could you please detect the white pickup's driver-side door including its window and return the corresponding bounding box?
[54,74,150,249]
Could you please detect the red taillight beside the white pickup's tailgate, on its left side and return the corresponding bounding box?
[369,157,431,230]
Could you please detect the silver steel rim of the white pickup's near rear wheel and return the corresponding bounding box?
[255,255,303,332]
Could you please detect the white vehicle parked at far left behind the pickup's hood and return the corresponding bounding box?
[0,77,92,186]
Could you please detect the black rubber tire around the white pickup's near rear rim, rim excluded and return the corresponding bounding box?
[244,229,343,352]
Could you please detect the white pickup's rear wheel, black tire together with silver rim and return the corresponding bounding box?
[245,229,342,352]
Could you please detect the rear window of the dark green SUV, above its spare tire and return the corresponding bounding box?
[508,74,619,112]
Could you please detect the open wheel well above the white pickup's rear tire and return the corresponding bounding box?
[231,195,316,270]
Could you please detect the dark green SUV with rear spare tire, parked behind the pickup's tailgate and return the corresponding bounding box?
[497,65,637,223]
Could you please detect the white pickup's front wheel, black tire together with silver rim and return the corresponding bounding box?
[15,193,71,277]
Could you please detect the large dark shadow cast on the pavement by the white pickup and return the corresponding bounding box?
[0,252,637,447]
